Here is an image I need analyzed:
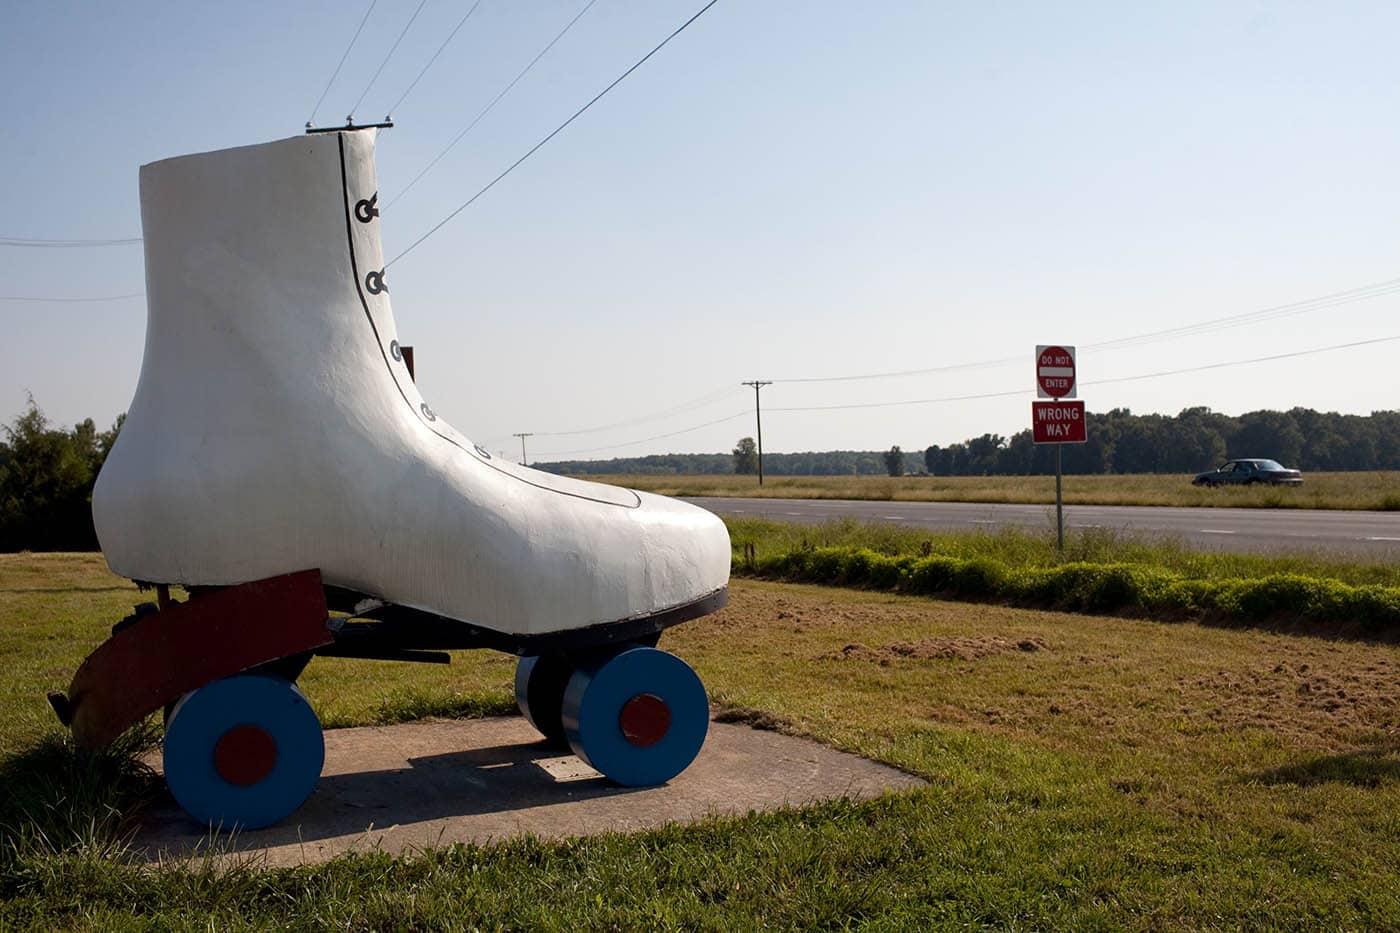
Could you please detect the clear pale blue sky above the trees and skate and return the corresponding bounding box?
[0,0,1400,461]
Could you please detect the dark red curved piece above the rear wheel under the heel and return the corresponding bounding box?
[49,570,332,748]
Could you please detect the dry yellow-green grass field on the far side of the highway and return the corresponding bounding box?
[584,471,1400,511]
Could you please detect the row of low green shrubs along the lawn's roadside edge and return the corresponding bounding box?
[734,548,1400,629]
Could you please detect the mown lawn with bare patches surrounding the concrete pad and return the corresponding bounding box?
[0,555,1400,930]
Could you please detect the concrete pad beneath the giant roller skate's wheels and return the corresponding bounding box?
[134,717,925,864]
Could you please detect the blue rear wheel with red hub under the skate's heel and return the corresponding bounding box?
[164,674,326,829]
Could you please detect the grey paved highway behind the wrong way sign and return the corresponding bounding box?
[687,496,1400,551]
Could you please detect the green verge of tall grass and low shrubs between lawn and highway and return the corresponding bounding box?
[728,518,1400,639]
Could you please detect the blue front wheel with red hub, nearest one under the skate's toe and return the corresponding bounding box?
[563,647,710,787]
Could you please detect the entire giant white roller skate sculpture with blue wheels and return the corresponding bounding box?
[50,130,729,828]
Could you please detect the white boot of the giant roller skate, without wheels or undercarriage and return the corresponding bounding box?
[92,130,729,635]
